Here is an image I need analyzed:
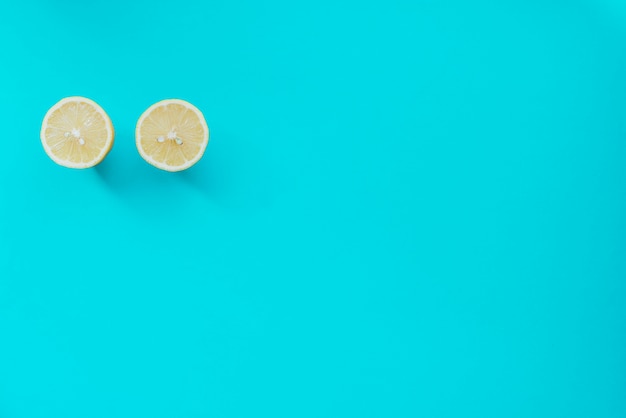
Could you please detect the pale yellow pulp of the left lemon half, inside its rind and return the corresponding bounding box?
[45,102,109,163]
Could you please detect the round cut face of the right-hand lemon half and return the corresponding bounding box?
[139,103,205,167]
